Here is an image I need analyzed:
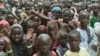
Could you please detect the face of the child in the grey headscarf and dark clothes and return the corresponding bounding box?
[11,27,23,43]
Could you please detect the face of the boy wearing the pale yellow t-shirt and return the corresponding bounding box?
[69,34,80,50]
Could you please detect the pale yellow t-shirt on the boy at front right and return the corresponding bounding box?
[64,47,89,56]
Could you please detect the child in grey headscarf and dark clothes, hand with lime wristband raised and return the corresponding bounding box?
[10,24,32,56]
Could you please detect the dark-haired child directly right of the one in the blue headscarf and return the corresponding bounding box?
[62,8,76,30]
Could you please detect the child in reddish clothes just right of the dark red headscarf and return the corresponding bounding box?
[47,20,59,50]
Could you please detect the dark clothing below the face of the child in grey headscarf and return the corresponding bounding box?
[11,40,28,56]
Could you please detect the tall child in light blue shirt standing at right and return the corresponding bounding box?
[77,10,98,56]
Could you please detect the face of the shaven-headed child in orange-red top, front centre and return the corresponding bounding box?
[39,39,51,53]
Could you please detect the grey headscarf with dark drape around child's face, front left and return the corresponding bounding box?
[11,24,28,56]
